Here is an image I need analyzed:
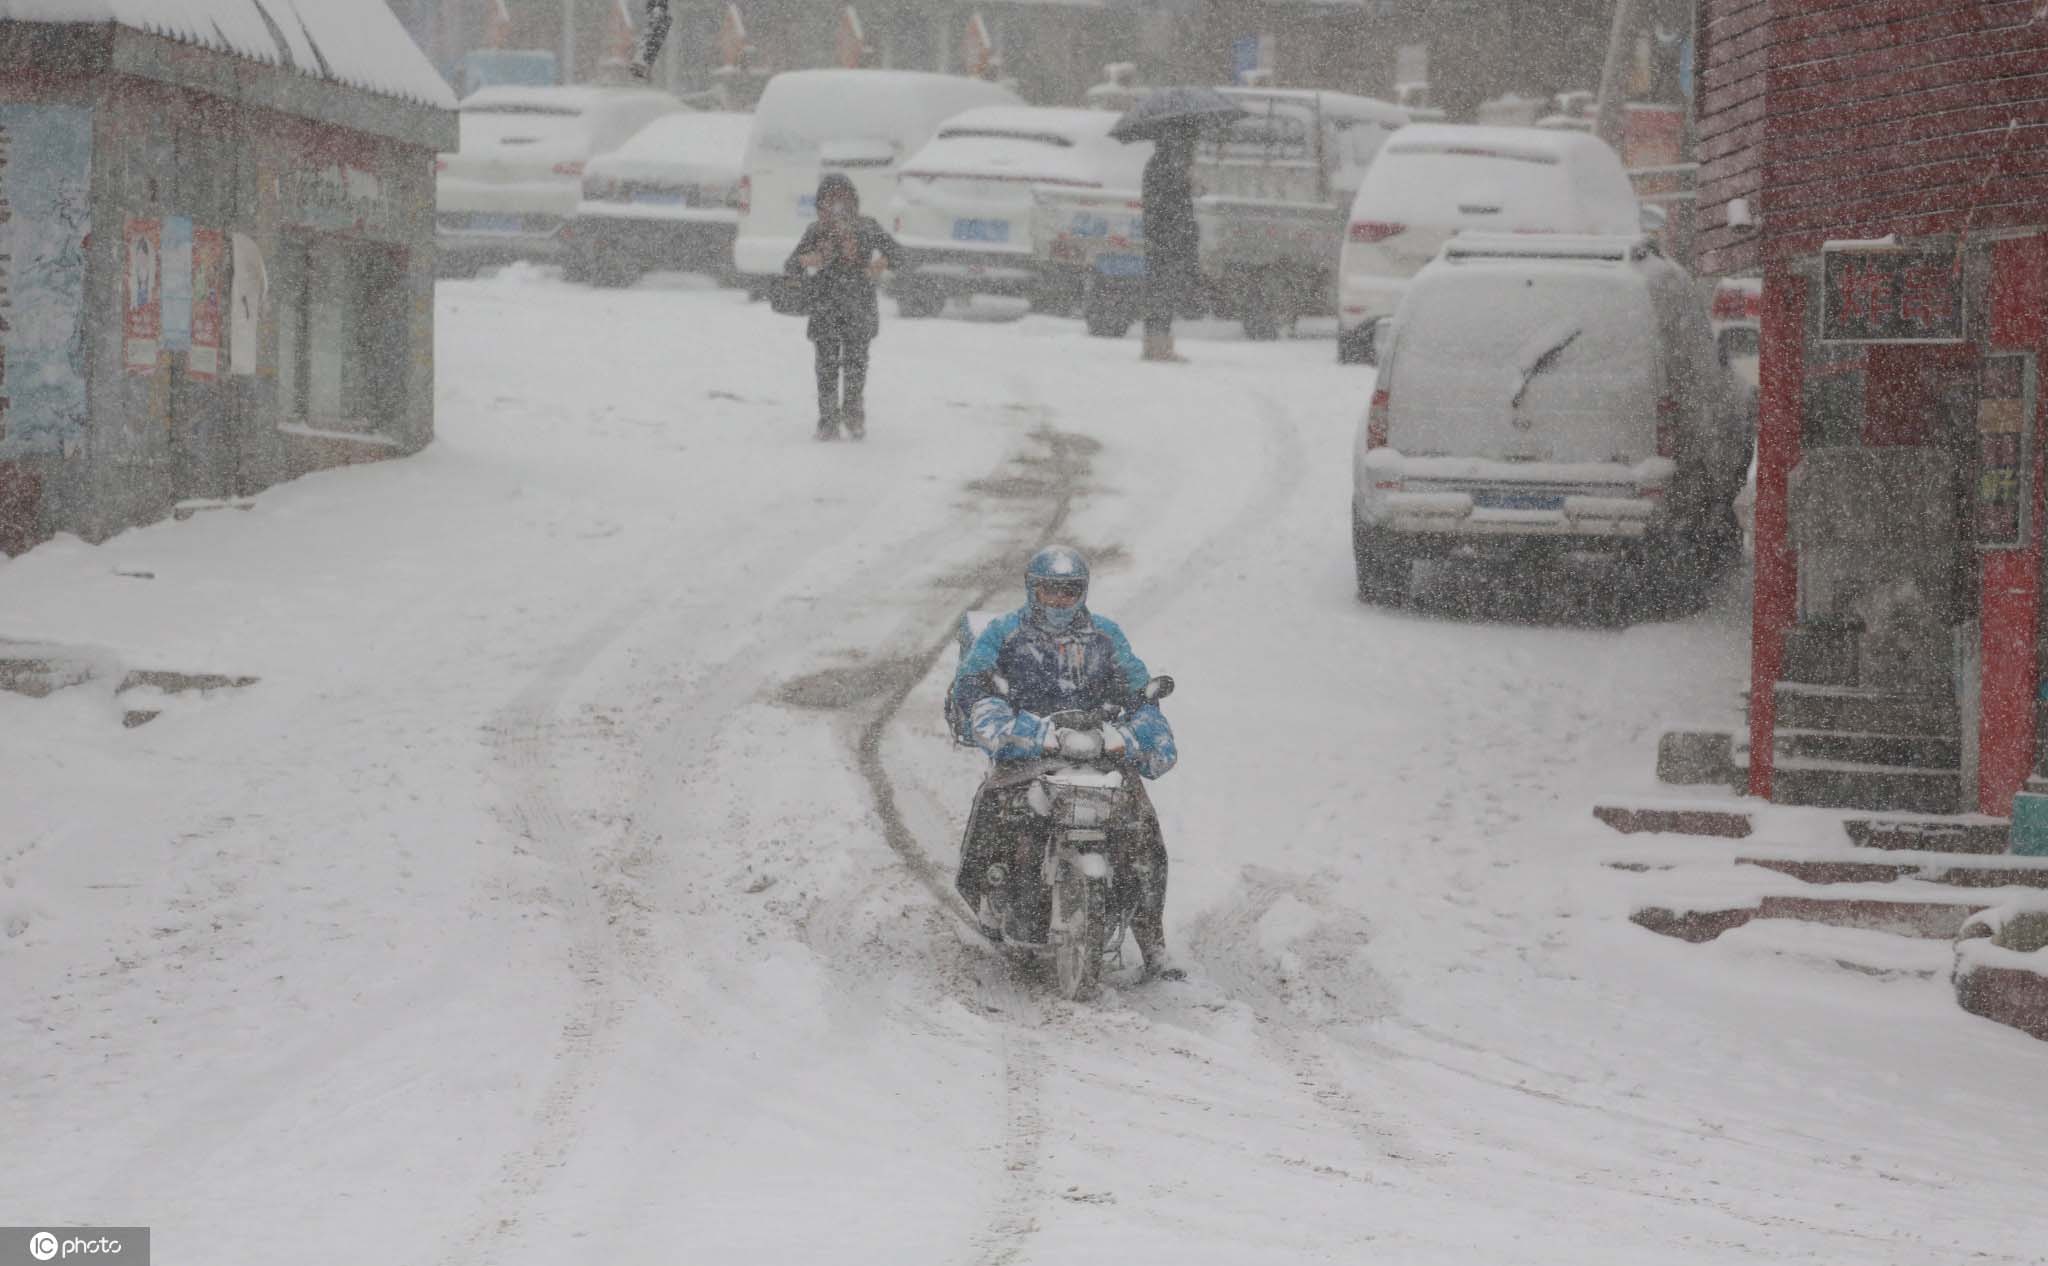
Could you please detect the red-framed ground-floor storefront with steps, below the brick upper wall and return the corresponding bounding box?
[1749,229,2048,815]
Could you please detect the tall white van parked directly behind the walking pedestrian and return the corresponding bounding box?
[733,70,1024,289]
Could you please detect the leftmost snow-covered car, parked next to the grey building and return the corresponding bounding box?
[434,86,686,275]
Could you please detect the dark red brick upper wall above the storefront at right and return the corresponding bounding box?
[1700,0,2048,272]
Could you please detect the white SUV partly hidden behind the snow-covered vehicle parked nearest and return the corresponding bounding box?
[1337,123,1640,363]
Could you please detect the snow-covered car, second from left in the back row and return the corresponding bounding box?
[561,111,754,285]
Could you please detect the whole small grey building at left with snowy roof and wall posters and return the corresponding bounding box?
[0,0,455,551]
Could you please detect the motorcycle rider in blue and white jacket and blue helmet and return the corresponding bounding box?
[952,545,1186,979]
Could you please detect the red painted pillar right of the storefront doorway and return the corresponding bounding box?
[1976,238,2048,815]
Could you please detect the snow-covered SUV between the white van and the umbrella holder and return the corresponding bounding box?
[885,107,1151,315]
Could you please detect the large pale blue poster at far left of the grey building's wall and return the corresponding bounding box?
[0,102,92,461]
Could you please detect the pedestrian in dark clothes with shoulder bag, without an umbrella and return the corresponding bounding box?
[782,172,903,440]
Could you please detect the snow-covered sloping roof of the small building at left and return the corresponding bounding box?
[0,0,455,109]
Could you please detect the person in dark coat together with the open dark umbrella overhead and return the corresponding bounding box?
[1110,88,1245,361]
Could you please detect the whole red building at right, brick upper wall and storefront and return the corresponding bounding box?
[1698,0,2048,815]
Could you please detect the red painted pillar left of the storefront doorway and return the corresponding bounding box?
[1749,264,1806,799]
